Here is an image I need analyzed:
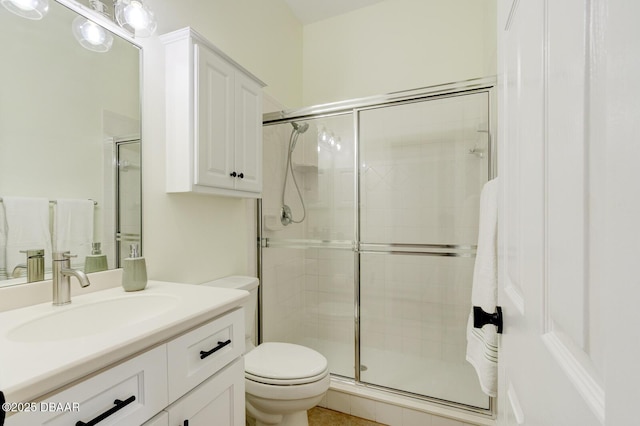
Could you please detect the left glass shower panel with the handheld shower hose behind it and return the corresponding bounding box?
[261,113,356,378]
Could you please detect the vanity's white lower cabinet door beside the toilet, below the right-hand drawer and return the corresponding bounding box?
[166,358,245,426]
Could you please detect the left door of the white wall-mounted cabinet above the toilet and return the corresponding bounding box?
[194,44,237,189]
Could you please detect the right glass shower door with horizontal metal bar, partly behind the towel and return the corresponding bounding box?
[358,92,490,409]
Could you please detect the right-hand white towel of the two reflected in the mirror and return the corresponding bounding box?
[53,199,94,268]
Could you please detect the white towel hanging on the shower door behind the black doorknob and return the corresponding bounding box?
[467,179,498,396]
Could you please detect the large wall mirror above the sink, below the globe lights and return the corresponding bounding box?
[0,0,142,286]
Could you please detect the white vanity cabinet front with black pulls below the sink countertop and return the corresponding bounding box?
[5,308,245,426]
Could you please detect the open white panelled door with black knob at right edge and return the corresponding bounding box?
[498,0,640,426]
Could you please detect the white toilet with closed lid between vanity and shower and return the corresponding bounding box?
[203,276,330,426]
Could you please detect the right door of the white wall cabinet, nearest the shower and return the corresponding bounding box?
[234,73,262,192]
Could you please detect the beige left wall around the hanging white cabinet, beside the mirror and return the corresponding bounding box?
[142,0,302,283]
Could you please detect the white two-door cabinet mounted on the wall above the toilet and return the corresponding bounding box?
[161,27,264,197]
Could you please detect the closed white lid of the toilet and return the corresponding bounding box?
[244,342,327,381]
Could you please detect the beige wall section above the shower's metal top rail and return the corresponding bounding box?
[303,0,496,105]
